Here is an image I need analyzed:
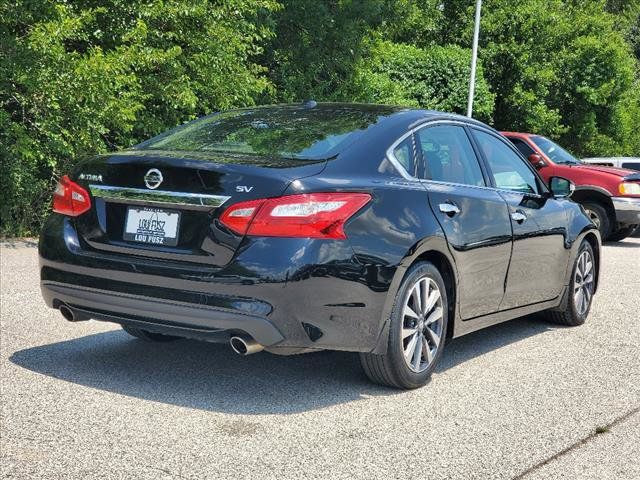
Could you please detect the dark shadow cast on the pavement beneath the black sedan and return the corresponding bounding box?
[10,317,556,414]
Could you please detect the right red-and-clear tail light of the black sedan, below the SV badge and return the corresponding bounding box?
[220,193,371,239]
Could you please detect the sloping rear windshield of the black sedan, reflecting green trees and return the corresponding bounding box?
[136,105,387,160]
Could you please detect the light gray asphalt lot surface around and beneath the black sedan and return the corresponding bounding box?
[0,239,640,480]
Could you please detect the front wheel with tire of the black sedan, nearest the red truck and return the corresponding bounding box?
[548,240,597,327]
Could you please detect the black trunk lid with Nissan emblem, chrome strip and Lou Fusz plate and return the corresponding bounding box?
[72,150,326,266]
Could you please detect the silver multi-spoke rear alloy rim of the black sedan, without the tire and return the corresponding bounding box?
[401,277,443,373]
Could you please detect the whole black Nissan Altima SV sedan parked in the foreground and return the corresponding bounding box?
[39,102,600,388]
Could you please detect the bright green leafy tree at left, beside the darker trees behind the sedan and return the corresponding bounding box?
[0,0,279,234]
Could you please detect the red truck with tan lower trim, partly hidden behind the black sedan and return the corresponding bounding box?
[502,132,640,241]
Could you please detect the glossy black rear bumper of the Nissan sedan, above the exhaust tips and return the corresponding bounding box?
[39,215,395,353]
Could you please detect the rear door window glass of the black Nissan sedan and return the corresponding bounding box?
[416,125,486,186]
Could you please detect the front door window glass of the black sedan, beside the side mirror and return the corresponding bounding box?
[473,129,540,194]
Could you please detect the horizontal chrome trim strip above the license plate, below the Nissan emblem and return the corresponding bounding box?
[89,184,231,209]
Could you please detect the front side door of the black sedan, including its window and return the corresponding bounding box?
[471,128,569,310]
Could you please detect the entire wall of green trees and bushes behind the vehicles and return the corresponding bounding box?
[0,0,640,235]
